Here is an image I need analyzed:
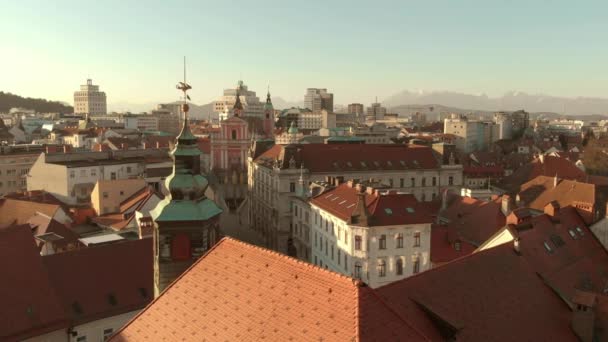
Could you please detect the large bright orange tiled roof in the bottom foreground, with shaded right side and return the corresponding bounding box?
[112,238,425,341]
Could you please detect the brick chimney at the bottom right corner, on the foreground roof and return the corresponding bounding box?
[571,290,597,342]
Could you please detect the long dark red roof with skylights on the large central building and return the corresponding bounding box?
[255,144,439,172]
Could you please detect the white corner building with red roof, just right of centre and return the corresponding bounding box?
[300,181,432,288]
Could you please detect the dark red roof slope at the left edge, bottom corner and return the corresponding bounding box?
[0,225,67,341]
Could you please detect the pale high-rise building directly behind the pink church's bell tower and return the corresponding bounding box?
[213,80,264,121]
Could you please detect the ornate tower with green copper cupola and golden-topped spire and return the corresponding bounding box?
[150,60,222,296]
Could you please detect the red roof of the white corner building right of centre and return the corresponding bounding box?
[311,181,433,226]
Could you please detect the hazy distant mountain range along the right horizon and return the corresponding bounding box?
[382,90,608,115]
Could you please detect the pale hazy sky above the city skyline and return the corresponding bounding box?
[0,0,608,108]
